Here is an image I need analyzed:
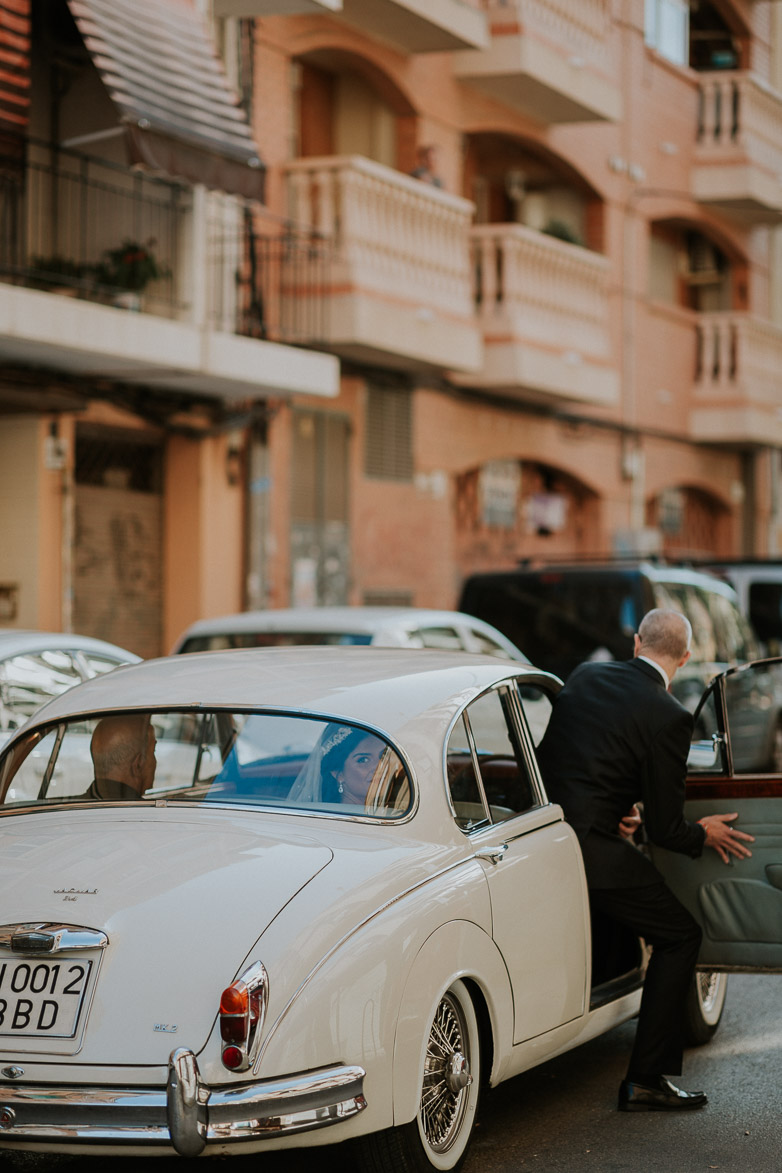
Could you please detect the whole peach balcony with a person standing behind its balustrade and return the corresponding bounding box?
[287,156,481,371]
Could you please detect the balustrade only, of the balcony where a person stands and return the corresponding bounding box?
[287,156,474,317]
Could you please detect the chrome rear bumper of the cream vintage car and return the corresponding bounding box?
[0,1047,367,1157]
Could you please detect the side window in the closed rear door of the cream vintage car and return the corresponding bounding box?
[448,690,537,829]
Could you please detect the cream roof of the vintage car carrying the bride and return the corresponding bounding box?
[15,645,558,737]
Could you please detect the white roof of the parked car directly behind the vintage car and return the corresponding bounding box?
[175,606,525,647]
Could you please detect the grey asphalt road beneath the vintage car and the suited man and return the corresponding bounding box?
[0,976,782,1173]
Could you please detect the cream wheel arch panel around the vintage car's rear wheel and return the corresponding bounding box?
[393,921,514,1126]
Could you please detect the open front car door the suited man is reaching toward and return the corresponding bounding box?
[652,658,782,972]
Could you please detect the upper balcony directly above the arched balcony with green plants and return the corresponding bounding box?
[454,0,621,126]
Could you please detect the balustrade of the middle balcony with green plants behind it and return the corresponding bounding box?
[471,224,608,359]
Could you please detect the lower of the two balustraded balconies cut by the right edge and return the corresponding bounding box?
[691,313,782,447]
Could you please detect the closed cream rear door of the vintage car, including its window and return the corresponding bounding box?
[448,683,589,1043]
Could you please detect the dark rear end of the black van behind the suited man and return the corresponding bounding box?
[460,569,653,678]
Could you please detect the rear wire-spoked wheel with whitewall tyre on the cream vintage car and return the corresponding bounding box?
[359,982,481,1173]
